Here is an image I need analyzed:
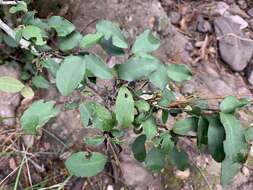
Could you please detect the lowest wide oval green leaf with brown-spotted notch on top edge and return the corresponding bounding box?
[65,152,106,177]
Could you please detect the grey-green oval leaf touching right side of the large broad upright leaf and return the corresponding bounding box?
[84,54,113,79]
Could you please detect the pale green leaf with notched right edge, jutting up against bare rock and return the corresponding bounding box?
[132,30,160,54]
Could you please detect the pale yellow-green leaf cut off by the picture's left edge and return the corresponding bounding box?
[0,76,25,93]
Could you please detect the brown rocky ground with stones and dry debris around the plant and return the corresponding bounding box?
[0,0,253,190]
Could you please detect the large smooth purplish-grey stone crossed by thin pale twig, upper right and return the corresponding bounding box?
[214,16,253,71]
